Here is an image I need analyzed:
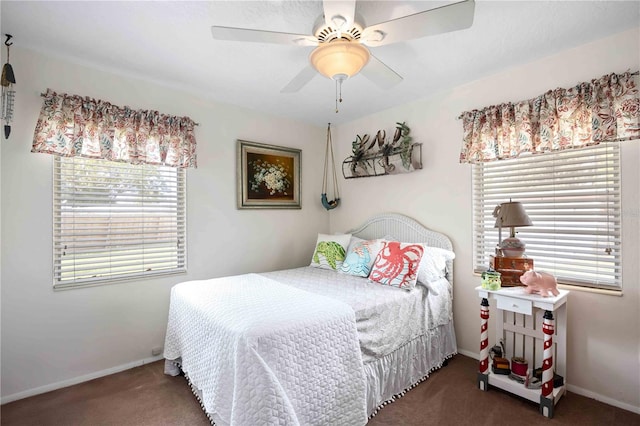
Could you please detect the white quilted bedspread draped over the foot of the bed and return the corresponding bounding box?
[164,274,367,426]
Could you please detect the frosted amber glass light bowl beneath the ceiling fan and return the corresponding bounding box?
[309,40,370,80]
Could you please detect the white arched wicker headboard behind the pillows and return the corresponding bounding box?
[348,213,453,285]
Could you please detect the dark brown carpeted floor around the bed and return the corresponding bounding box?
[0,355,640,426]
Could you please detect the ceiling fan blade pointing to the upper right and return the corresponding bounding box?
[361,0,475,47]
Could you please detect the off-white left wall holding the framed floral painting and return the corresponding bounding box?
[0,45,329,402]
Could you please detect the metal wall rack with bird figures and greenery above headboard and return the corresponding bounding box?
[342,122,422,179]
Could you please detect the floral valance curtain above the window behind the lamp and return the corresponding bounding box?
[460,72,640,163]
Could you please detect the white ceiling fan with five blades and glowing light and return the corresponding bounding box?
[211,0,475,93]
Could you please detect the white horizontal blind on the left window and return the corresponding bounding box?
[53,157,186,288]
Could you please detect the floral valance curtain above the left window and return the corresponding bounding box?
[31,89,196,168]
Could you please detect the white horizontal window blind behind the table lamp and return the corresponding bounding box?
[473,144,622,290]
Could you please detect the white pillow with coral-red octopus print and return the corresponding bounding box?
[369,241,424,290]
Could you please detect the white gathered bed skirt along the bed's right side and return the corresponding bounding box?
[364,321,458,417]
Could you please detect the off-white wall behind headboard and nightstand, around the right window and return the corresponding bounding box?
[330,29,640,412]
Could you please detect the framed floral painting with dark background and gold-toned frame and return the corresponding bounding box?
[237,140,302,209]
